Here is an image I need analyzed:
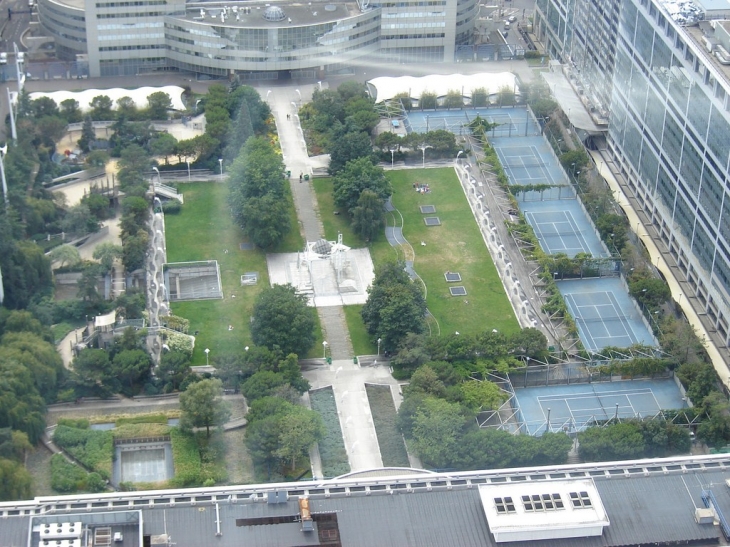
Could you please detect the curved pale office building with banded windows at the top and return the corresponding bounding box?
[38,0,479,79]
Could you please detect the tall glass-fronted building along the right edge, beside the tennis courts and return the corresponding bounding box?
[536,0,730,345]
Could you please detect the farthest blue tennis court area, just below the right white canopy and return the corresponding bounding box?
[403,107,540,138]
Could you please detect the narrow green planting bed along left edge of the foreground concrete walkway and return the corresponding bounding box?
[309,387,350,477]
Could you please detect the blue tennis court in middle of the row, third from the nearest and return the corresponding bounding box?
[521,199,610,258]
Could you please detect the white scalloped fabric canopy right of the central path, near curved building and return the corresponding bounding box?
[367,72,519,103]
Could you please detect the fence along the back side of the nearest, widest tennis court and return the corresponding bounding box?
[509,363,672,389]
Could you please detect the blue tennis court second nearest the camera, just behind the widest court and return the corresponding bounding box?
[557,277,657,351]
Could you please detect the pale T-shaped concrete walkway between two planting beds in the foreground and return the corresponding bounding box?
[303,359,400,471]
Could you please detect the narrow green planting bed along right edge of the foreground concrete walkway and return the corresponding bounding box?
[365,384,410,467]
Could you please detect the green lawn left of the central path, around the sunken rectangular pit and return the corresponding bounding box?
[165,182,321,365]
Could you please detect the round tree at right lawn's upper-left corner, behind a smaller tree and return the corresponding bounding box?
[332,158,393,214]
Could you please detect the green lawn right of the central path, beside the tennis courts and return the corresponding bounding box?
[314,168,519,338]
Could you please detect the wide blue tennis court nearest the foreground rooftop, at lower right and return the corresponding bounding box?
[515,378,687,435]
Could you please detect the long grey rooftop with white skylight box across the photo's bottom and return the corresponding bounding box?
[0,454,730,547]
